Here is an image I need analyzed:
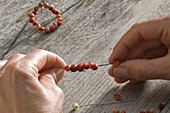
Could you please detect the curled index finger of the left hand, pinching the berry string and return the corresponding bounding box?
[22,49,66,74]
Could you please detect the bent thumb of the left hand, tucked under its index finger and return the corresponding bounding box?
[38,68,64,113]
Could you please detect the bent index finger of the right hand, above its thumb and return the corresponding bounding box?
[109,18,165,63]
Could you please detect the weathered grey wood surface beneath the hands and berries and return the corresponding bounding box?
[0,0,170,113]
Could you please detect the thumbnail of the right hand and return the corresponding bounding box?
[114,66,126,78]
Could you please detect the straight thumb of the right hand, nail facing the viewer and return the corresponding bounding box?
[114,55,170,81]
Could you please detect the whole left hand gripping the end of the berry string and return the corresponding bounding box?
[0,49,65,113]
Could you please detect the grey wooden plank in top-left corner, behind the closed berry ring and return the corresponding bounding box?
[0,0,79,55]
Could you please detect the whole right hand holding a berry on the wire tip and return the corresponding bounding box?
[109,16,170,83]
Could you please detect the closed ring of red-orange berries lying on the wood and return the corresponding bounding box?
[28,3,63,33]
